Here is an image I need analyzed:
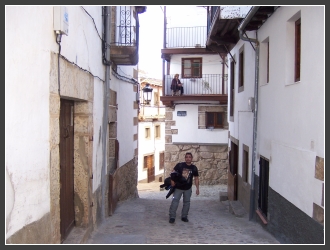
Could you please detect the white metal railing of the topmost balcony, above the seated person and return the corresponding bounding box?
[166,26,207,48]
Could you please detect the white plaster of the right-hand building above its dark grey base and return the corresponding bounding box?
[228,6,324,216]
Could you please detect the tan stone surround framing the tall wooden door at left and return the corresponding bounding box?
[48,53,94,243]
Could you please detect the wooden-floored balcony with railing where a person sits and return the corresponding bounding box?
[160,74,228,106]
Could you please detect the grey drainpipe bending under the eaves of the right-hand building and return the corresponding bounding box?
[238,6,260,220]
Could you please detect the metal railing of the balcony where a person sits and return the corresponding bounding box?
[164,74,228,95]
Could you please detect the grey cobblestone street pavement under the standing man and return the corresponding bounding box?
[86,182,280,245]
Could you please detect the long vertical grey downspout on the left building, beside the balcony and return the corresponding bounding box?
[101,6,111,217]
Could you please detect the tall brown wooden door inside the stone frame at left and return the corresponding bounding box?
[60,100,74,242]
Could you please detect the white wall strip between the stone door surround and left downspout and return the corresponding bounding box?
[54,6,105,191]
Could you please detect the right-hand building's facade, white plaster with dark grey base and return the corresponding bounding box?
[228,6,325,244]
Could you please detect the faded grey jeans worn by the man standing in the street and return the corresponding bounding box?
[169,188,192,219]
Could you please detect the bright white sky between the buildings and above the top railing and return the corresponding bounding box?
[138,5,206,79]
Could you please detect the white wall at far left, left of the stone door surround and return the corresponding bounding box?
[5,6,57,236]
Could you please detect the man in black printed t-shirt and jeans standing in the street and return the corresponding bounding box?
[169,152,199,223]
